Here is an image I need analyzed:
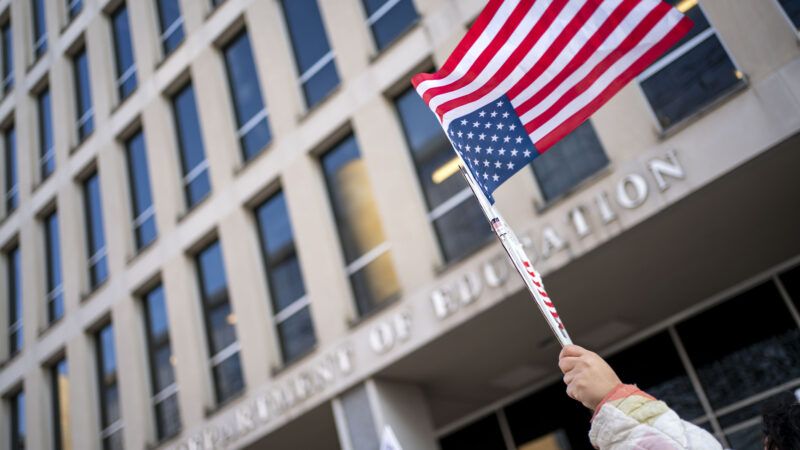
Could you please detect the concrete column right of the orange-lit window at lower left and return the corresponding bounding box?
[67,330,103,450]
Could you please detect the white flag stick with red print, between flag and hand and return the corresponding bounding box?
[450,153,572,347]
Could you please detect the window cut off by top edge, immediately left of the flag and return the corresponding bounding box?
[364,0,419,50]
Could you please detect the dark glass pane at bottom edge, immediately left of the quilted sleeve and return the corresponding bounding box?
[505,381,592,450]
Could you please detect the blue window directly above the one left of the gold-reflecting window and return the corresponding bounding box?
[222,31,270,160]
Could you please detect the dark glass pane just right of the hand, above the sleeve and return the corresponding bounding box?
[608,331,705,420]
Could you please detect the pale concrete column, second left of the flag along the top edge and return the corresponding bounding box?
[245,1,304,141]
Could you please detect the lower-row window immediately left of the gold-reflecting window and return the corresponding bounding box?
[256,192,317,362]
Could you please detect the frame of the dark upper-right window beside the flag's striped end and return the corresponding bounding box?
[634,1,748,133]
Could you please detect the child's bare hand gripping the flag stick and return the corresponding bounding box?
[558,345,621,411]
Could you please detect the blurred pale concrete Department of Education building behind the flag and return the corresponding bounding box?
[0,0,800,450]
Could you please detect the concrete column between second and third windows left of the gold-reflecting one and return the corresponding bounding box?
[162,255,212,429]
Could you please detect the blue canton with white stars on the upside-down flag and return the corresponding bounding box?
[447,95,539,203]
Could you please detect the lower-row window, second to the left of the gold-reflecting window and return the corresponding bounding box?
[195,241,244,403]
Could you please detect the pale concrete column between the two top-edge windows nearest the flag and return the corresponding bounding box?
[318,0,375,84]
